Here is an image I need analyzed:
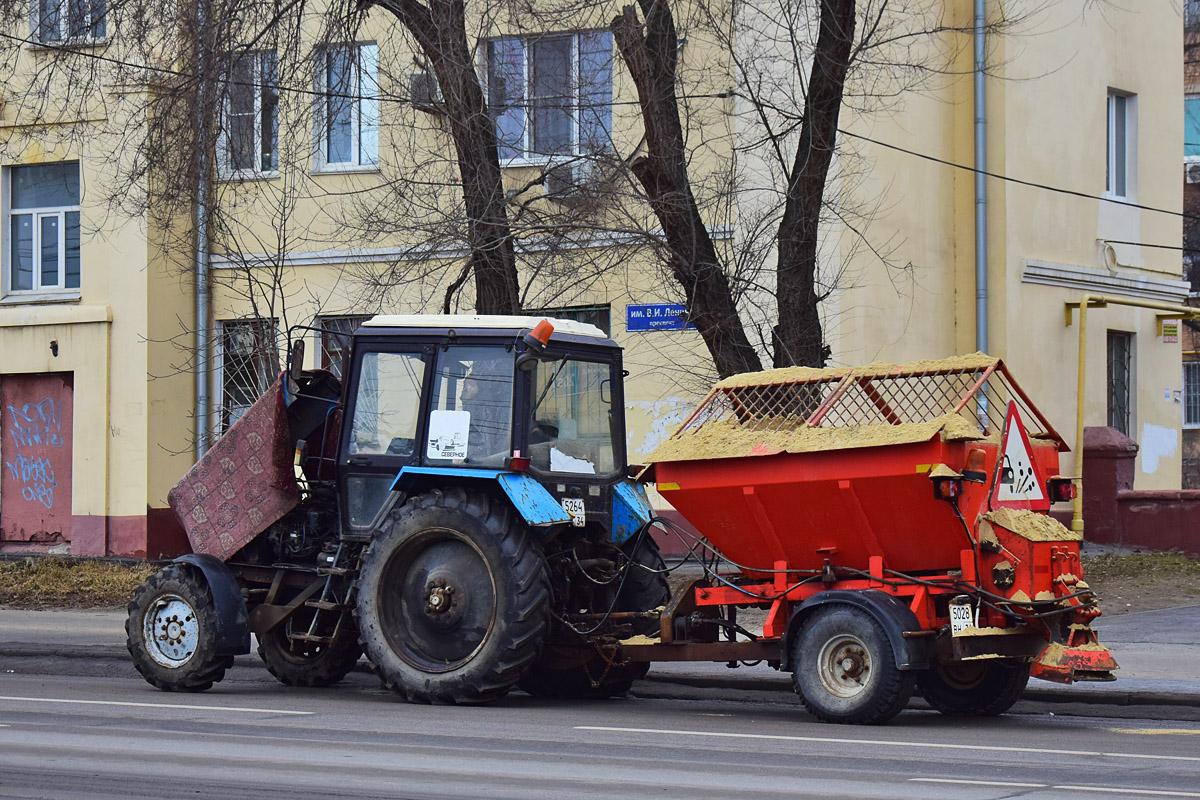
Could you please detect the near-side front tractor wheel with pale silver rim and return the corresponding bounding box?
[125,564,233,692]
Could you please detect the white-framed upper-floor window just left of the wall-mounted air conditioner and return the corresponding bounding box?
[313,42,379,173]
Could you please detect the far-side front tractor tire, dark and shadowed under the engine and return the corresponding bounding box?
[258,608,362,686]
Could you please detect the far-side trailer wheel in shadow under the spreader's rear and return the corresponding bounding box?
[917,660,1030,717]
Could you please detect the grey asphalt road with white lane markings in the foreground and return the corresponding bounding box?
[0,662,1200,800]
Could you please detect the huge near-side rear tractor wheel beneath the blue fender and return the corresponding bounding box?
[358,488,550,704]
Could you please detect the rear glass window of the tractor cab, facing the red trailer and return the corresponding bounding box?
[529,357,617,475]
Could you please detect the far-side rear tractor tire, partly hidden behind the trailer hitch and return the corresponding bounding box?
[520,535,671,698]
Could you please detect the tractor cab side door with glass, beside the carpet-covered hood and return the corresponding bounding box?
[337,342,433,539]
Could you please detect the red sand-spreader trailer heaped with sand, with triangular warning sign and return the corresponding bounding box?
[620,354,1117,723]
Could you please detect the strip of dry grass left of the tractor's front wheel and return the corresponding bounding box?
[0,557,157,608]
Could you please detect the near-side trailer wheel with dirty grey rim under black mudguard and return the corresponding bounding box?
[792,604,916,724]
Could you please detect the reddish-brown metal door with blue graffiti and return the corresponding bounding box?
[0,372,74,545]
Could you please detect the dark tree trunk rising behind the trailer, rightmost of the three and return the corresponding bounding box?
[774,0,854,367]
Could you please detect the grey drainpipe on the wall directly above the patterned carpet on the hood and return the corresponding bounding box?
[196,1,212,461]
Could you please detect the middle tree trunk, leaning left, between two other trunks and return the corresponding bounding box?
[612,0,762,378]
